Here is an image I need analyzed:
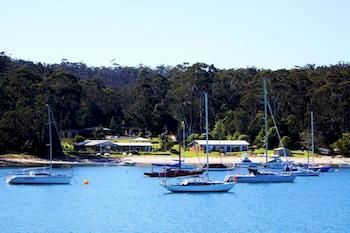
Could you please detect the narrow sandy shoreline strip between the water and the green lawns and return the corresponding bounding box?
[0,155,350,168]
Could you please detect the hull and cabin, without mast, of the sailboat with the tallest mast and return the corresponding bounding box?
[225,168,295,183]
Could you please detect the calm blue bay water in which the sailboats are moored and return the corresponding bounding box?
[0,167,350,233]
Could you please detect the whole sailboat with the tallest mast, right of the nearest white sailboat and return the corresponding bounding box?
[226,78,295,183]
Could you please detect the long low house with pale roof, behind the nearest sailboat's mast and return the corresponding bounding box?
[188,140,249,152]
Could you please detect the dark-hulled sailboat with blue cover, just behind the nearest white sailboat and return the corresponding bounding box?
[144,122,204,177]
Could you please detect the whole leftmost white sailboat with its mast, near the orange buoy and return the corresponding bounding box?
[6,105,73,184]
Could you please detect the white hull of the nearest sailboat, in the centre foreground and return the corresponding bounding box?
[165,183,234,193]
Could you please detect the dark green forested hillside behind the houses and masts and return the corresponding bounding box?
[0,53,350,154]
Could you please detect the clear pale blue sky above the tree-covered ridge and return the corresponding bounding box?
[0,0,350,69]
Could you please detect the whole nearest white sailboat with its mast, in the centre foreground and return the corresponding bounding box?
[161,93,235,192]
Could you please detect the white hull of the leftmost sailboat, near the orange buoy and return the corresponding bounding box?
[6,174,73,184]
